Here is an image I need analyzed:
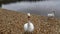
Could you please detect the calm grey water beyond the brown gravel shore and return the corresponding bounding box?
[2,1,60,18]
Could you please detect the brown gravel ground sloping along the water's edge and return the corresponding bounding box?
[0,9,60,34]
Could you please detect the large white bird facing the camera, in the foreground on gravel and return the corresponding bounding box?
[24,13,34,32]
